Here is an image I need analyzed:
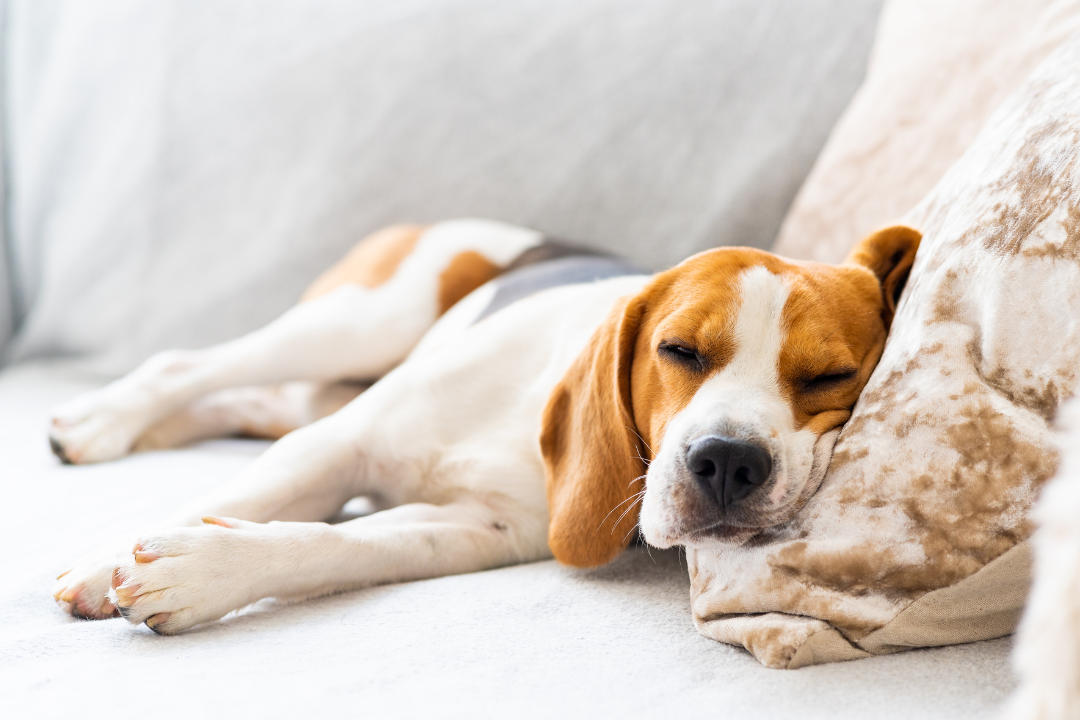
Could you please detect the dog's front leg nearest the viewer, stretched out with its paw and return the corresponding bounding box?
[112,502,536,635]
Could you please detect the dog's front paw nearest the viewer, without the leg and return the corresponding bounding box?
[109,518,268,635]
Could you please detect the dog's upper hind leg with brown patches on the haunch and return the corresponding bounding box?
[50,220,541,463]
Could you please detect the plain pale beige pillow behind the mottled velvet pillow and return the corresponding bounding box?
[774,0,1080,262]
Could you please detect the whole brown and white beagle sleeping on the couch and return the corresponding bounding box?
[50,220,920,635]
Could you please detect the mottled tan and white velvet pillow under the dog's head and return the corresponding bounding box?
[687,37,1080,667]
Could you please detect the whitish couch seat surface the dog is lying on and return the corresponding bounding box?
[0,367,1014,720]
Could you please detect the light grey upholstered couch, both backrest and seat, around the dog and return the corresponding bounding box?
[0,0,1053,719]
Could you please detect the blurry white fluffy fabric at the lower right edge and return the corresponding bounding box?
[1004,399,1080,720]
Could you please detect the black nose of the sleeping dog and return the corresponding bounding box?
[686,435,772,510]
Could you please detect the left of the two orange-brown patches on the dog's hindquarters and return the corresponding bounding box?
[300,225,428,302]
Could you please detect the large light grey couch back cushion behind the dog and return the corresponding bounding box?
[8,0,880,375]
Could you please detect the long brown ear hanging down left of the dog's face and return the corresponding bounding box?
[540,298,645,568]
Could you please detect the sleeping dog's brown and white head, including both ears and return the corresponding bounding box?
[540,227,921,567]
